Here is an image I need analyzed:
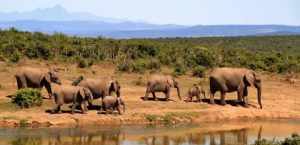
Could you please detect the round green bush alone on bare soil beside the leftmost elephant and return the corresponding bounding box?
[12,88,43,108]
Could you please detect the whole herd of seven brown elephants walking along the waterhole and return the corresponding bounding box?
[15,67,262,114]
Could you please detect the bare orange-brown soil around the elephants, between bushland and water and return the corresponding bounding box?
[0,60,300,127]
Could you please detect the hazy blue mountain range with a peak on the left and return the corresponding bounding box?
[0,5,300,38]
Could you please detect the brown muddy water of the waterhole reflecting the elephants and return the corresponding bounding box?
[0,121,300,145]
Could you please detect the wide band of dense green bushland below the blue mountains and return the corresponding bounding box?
[0,28,300,76]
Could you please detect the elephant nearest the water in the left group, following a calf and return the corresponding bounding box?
[52,85,93,114]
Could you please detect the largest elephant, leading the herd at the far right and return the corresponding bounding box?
[209,67,262,109]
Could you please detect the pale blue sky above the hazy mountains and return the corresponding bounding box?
[0,0,300,25]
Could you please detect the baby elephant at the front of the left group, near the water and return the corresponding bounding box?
[102,96,125,115]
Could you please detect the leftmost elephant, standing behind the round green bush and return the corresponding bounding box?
[15,67,61,99]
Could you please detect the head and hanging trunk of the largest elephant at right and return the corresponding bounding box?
[242,71,262,109]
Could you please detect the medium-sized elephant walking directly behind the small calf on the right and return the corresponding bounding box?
[144,74,181,100]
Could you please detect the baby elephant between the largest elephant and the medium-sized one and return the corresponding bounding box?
[185,84,206,102]
